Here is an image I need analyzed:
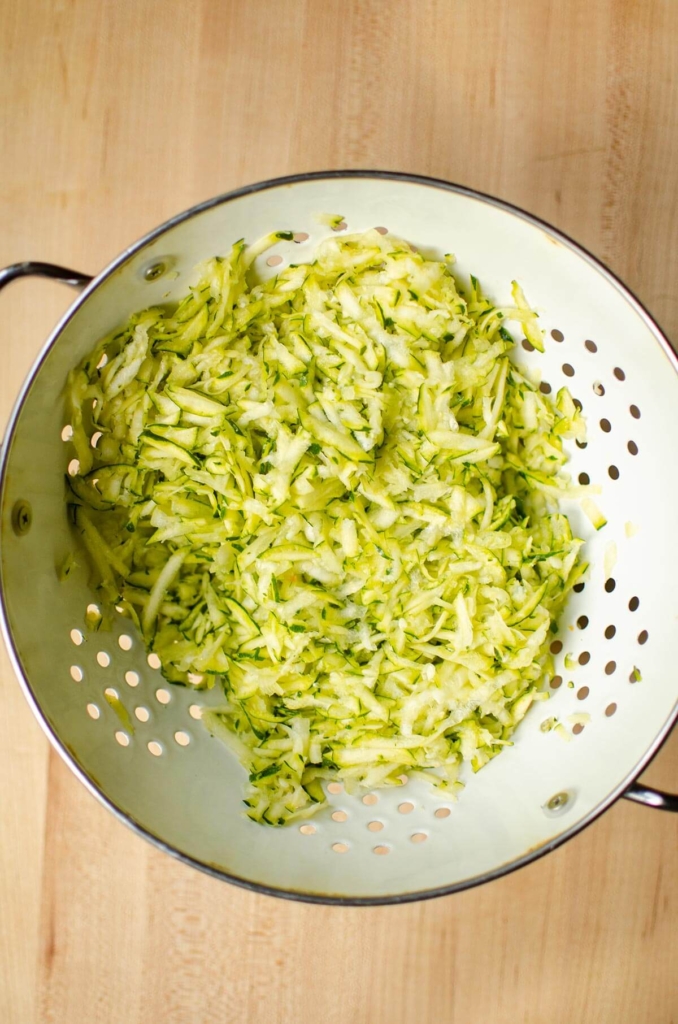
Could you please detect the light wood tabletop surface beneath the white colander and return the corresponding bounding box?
[0,0,678,1024]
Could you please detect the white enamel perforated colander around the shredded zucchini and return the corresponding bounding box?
[0,172,678,903]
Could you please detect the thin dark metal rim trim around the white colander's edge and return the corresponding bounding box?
[0,170,678,906]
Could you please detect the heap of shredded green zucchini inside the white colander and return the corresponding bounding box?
[69,230,584,824]
